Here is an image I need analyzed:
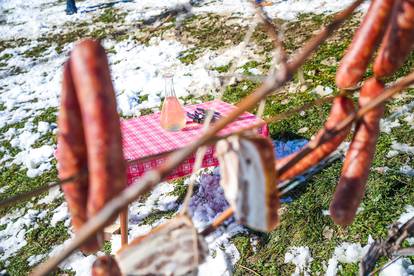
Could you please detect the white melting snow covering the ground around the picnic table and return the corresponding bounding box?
[0,0,414,275]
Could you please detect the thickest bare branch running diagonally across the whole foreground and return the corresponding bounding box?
[33,0,363,275]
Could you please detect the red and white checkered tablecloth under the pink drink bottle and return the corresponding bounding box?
[121,100,269,185]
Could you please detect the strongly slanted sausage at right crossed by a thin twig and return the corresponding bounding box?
[276,96,355,182]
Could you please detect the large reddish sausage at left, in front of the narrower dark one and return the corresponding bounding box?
[70,39,126,227]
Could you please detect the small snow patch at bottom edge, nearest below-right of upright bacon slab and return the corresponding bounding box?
[285,246,313,275]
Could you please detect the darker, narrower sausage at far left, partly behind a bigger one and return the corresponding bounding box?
[56,63,99,253]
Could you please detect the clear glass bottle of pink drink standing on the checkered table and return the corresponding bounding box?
[160,74,186,131]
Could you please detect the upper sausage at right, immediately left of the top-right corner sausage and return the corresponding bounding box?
[336,0,395,89]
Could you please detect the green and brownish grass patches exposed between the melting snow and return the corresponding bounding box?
[0,3,414,275]
